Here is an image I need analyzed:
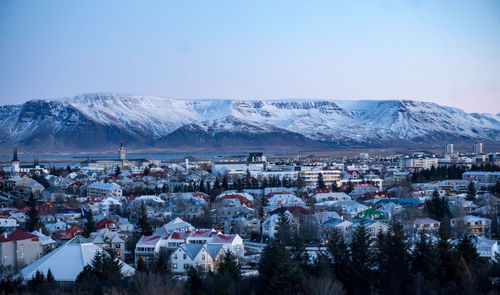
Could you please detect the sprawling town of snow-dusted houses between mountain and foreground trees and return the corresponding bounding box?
[0,141,500,294]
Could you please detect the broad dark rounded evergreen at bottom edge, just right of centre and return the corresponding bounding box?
[258,242,304,295]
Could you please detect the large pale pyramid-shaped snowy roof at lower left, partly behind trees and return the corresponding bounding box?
[19,236,135,282]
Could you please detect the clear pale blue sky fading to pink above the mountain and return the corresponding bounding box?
[0,0,500,113]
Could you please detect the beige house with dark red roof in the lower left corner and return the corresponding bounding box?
[0,229,43,274]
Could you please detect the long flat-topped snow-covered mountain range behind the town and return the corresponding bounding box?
[0,93,500,152]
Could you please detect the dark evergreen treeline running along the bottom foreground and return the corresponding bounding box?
[0,224,500,295]
